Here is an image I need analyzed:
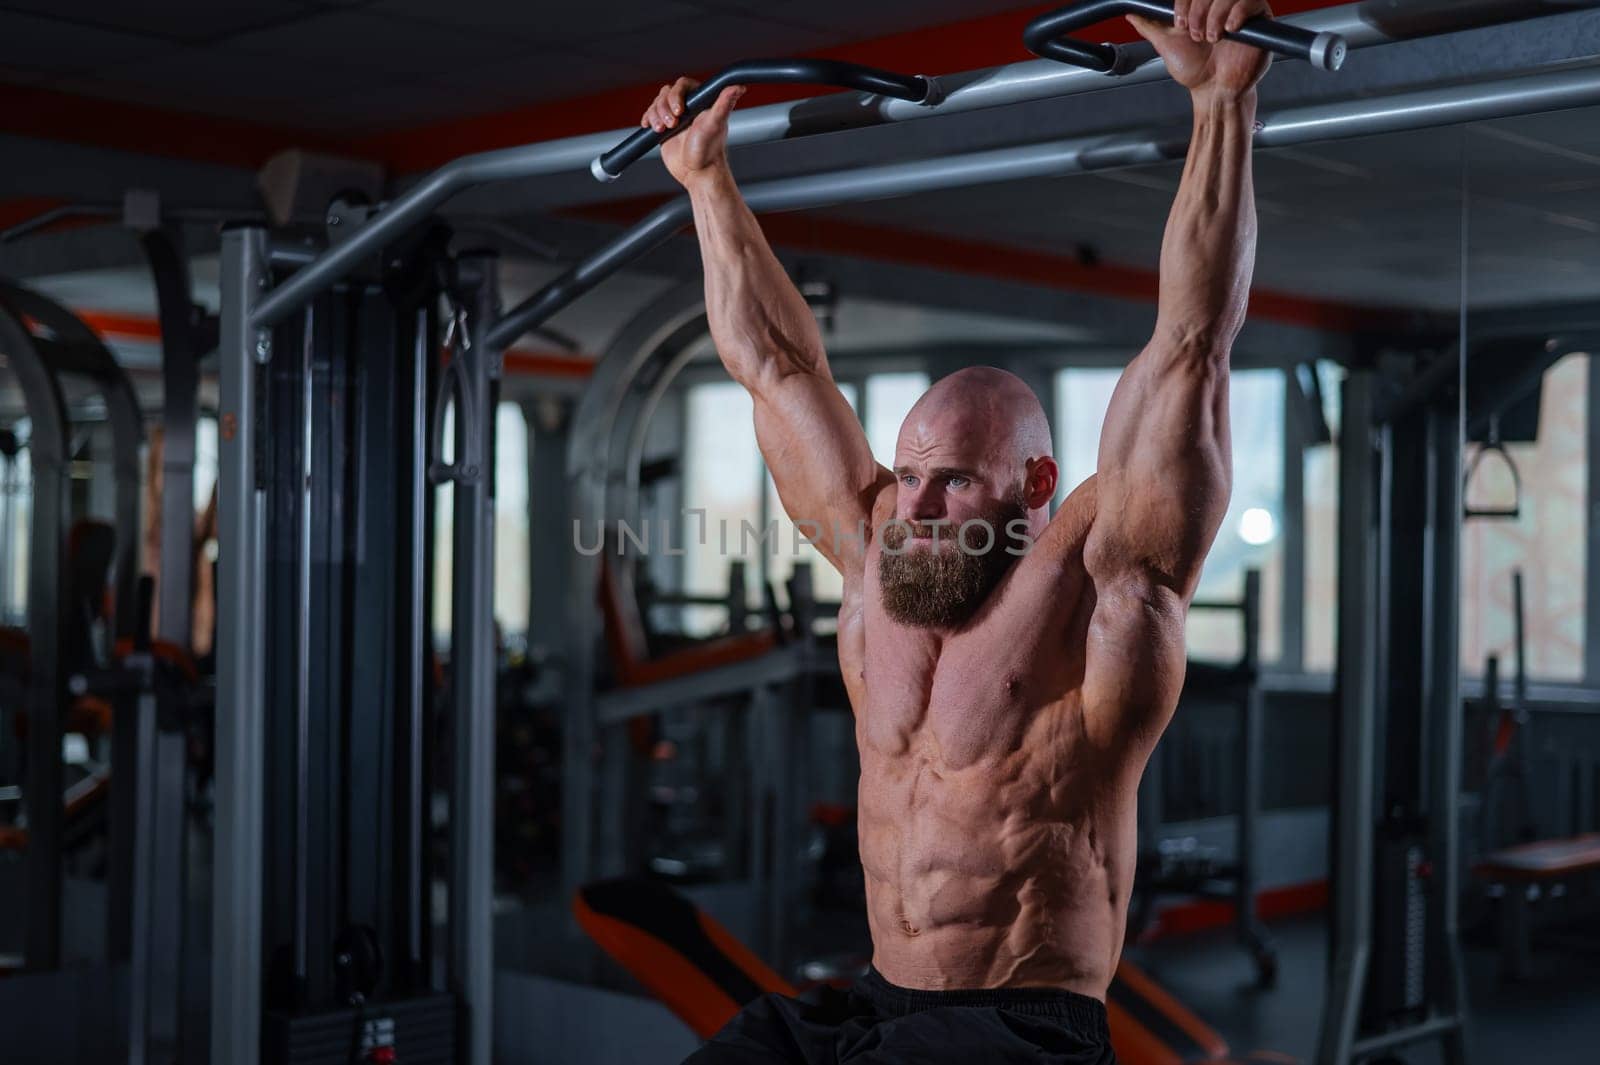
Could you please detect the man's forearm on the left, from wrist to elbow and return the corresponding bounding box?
[690,168,827,390]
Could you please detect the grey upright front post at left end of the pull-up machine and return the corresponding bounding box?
[210,227,272,1065]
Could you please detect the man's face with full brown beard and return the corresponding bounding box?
[878,404,1029,628]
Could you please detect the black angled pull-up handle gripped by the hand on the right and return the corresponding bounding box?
[1022,0,1349,75]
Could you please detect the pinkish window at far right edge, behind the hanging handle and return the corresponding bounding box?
[1461,355,1589,681]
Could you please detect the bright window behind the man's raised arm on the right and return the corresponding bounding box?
[1056,368,1285,662]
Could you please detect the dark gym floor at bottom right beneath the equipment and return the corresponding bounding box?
[1130,916,1600,1065]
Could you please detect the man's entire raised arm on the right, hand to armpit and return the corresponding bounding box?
[1083,0,1269,745]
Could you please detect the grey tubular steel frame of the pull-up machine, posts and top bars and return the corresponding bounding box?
[213,5,1600,1065]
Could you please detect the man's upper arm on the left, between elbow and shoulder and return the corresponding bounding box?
[755,374,894,572]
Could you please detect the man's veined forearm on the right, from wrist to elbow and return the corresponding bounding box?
[1157,90,1256,355]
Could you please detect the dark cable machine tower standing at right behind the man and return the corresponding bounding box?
[1317,357,1467,1065]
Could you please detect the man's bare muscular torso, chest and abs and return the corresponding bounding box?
[840,498,1164,998]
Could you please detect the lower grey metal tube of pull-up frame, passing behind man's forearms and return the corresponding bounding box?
[488,64,1600,347]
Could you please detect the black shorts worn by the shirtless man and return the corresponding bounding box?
[683,969,1117,1065]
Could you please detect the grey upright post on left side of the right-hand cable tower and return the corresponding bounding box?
[1317,369,1379,1065]
